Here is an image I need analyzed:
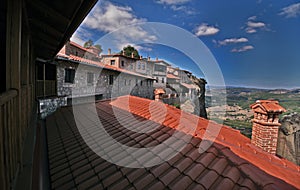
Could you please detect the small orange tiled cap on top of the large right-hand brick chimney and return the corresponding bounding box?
[250,100,286,113]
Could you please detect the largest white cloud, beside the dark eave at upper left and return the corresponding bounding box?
[74,2,156,49]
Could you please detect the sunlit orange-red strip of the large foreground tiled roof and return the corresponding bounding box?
[111,96,300,189]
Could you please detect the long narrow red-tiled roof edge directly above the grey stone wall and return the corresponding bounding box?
[56,53,154,80]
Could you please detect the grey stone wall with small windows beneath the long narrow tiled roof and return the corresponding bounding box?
[57,60,154,103]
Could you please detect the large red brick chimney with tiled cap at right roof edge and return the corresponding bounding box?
[250,100,286,155]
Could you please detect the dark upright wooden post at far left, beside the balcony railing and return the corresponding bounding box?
[5,0,22,188]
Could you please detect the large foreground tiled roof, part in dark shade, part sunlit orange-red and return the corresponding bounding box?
[46,96,300,189]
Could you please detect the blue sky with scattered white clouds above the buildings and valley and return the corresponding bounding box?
[71,0,300,88]
